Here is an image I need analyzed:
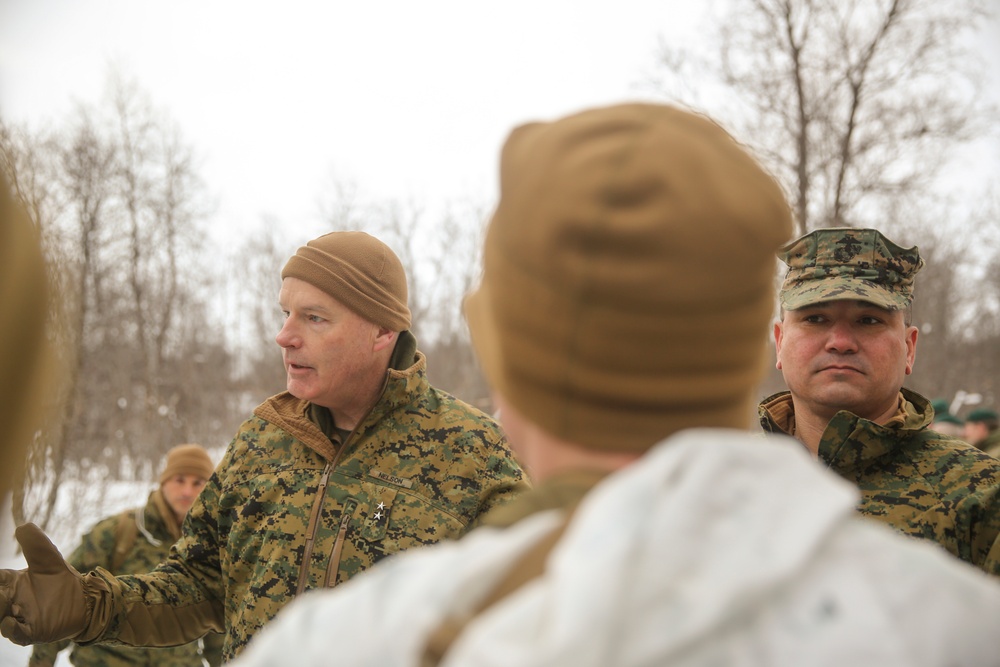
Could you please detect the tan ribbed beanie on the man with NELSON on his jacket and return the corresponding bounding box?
[281,232,410,331]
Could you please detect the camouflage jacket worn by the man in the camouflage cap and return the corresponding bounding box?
[758,389,1000,576]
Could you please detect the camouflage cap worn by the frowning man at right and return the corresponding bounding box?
[778,227,924,310]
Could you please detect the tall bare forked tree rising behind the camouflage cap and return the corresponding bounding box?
[661,0,995,232]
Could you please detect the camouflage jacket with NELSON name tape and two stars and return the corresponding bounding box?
[78,342,527,660]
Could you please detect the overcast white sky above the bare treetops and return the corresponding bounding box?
[0,0,711,245]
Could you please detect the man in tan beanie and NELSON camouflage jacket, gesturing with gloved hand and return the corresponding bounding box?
[0,232,525,660]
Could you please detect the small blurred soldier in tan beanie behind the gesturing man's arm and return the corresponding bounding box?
[28,444,222,667]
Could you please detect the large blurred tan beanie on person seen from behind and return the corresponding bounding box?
[465,104,792,452]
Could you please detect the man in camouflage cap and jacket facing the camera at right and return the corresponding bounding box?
[758,228,1000,575]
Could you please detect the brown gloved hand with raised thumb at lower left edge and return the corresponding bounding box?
[0,523,87,646]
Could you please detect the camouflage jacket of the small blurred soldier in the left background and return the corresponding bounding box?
[28,489,222,667]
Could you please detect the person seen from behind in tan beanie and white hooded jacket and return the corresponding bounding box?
[227,104,1000,667]
